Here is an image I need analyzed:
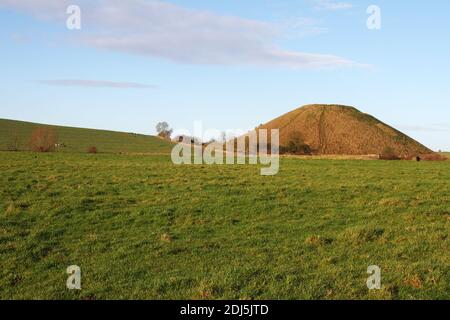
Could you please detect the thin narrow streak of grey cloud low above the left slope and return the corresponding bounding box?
[37,79,156,89]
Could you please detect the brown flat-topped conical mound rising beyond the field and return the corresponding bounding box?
[258,105,432,157]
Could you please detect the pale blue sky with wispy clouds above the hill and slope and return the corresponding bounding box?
[0,0,450,151]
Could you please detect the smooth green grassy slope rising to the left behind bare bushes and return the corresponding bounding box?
[0,119,171,153]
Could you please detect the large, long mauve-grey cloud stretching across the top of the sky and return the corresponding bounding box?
[0,0,362,68]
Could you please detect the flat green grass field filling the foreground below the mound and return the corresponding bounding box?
[0,152,450,299]
